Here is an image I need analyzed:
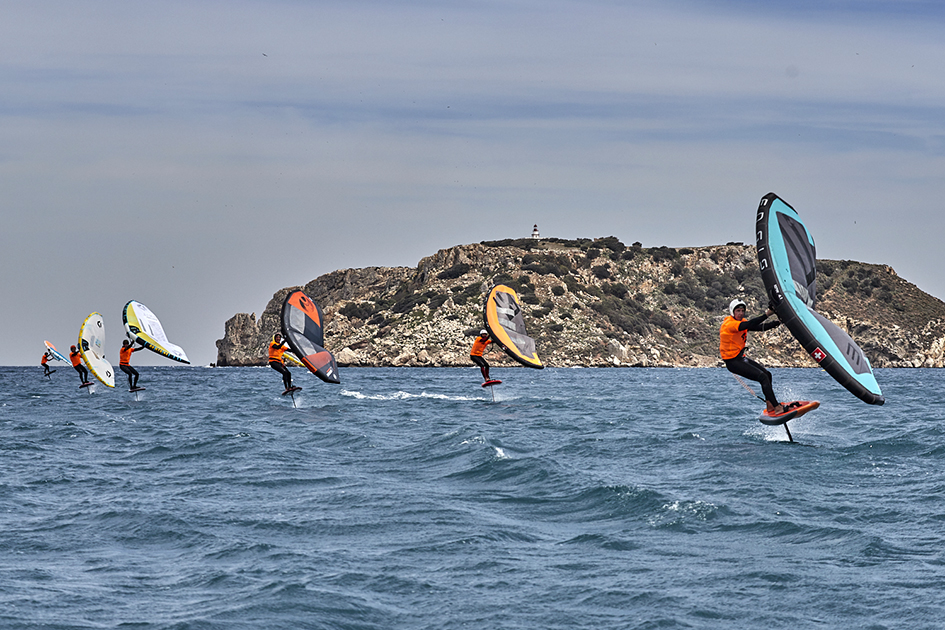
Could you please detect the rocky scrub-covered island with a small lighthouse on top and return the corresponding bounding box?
[216,241,945,367]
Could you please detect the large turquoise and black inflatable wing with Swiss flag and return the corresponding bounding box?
[755,193,886,405]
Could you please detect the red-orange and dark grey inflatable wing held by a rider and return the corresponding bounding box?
[282,291,341,383]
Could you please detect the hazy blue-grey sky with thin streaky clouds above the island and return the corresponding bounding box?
[0,0,945,369]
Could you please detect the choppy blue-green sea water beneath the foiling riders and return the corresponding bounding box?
[0,364,945,630]
